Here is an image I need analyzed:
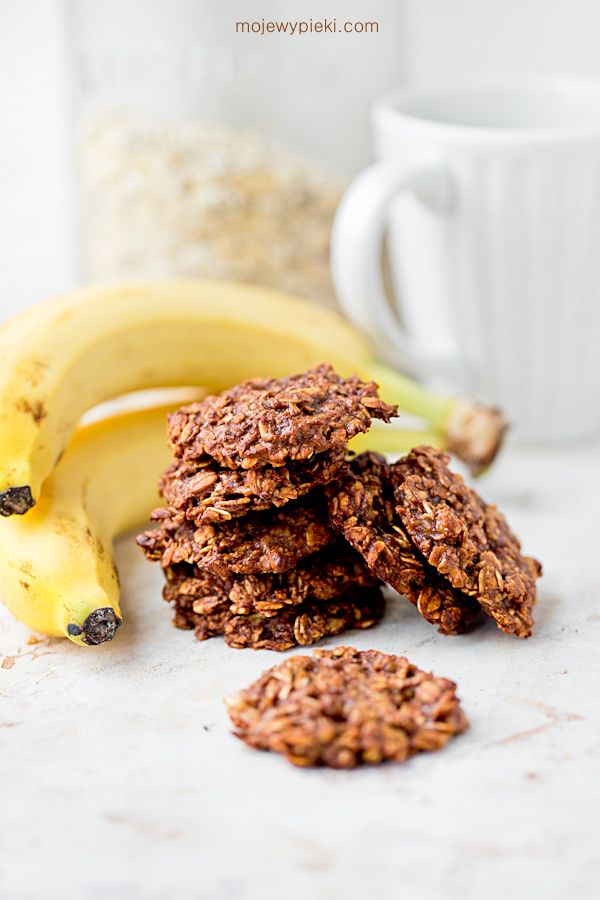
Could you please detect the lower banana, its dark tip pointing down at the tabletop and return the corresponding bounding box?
[0,403,185,644]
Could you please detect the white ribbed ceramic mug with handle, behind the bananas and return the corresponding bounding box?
[332,77,600,441]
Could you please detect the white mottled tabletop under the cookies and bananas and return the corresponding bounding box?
[0,446,600,900]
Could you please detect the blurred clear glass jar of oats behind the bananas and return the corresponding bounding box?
[67,0,402,305]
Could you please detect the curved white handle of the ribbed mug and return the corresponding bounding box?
[331,161,456,375]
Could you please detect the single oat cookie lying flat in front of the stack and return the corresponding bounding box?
[226,647,468,769]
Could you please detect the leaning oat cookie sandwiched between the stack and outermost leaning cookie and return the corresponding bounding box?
[325,453,480,634]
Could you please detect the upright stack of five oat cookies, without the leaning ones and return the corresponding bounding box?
[138,365,396,650]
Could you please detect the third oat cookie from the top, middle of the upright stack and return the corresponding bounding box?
[138,491,335,575]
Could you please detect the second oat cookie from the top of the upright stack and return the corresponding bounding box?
[160,448,346,526]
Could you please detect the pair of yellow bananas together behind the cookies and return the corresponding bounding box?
[0,281,504,645]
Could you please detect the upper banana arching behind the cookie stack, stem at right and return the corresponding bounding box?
[0,280,503,516]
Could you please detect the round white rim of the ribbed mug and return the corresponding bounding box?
[373,73,600,143]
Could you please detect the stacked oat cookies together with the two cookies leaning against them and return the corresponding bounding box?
[138,365,541,650]
